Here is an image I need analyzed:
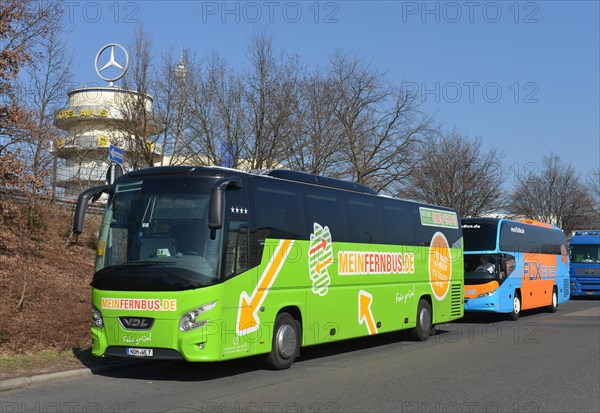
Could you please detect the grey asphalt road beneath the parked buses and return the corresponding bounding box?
[0,300,600,413]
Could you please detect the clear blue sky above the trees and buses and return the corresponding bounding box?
[64,0,600,186]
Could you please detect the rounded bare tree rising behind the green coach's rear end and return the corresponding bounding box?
[400,130,505,217]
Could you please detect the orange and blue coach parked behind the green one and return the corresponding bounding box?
[462,218,570,320]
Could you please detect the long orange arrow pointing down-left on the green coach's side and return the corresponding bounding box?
[237,240,294,336]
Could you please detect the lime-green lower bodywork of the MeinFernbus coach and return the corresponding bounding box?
[92,239,464,361]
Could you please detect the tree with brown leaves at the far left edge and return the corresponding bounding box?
[0,0,61,310]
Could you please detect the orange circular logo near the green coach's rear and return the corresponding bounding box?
[429,232,452,301]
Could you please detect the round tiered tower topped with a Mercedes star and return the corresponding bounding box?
[54,43,161,198]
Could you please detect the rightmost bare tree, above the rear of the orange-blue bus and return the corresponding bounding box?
[508,153,600,233]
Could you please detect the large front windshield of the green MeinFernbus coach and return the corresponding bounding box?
[92,177,221,291]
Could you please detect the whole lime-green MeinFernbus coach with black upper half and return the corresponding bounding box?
[73,166,464,369]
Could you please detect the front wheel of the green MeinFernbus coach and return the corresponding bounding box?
[266,313,302,370]
